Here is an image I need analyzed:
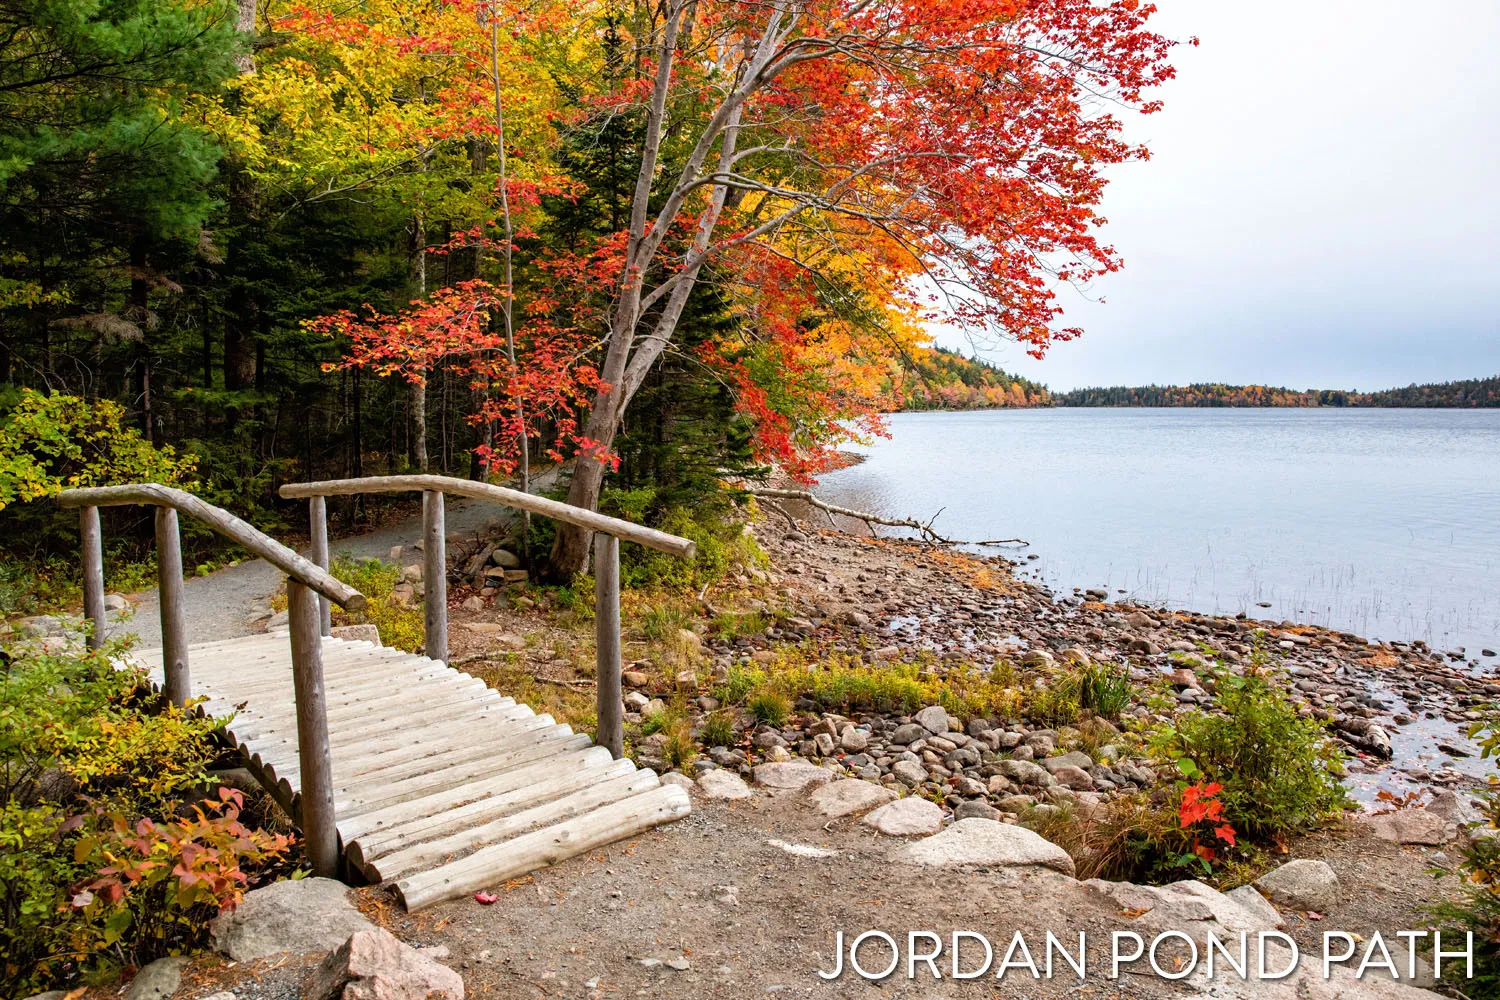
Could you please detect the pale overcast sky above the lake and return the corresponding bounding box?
[939,0,1500,390]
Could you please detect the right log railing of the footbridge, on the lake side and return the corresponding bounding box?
[281,475,698,757]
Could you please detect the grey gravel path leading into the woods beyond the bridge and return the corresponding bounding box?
[110,472,558,649]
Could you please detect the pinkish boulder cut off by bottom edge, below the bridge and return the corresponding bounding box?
[303,928,464,1000]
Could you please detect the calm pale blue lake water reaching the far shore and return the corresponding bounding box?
[818,409,1500,663]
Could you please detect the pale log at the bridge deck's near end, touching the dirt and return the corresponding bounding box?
[396,784,693,912]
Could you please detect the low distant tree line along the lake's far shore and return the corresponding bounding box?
[1052,375,1500,408]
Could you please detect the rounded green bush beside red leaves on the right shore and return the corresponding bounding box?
[1151,663,1347,835]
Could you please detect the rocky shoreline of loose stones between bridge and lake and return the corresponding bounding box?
[615,520,1500,819]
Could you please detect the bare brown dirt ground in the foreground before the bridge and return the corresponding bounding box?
[155,792,1464,1000]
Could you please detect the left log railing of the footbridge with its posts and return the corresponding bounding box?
[57,483,365,877]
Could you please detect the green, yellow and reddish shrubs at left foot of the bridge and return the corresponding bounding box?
[0,645,288,996]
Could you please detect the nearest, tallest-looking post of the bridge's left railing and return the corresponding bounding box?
[287,580,339,879]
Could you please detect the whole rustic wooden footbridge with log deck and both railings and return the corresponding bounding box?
[59,475,693,910]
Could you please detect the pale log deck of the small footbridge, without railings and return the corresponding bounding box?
[131,633,690,910]
